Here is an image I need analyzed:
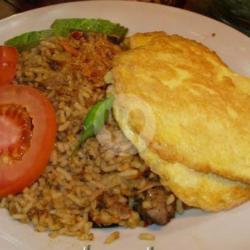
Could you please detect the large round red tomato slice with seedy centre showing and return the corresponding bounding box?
[0,84,56,197]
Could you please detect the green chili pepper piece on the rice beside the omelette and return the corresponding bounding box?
[73,96,114,154]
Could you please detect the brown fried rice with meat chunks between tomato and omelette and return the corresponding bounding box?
[0,32,182,240]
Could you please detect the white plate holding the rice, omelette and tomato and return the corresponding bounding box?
[0,1,250,250]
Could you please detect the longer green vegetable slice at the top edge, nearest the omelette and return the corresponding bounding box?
[51,18,128,39]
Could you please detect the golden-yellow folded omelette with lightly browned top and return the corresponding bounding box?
[112,32,250,211]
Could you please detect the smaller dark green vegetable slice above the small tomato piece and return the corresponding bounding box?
[4,30,53,51]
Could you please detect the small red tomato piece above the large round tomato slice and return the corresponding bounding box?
[0,45,18,85]
